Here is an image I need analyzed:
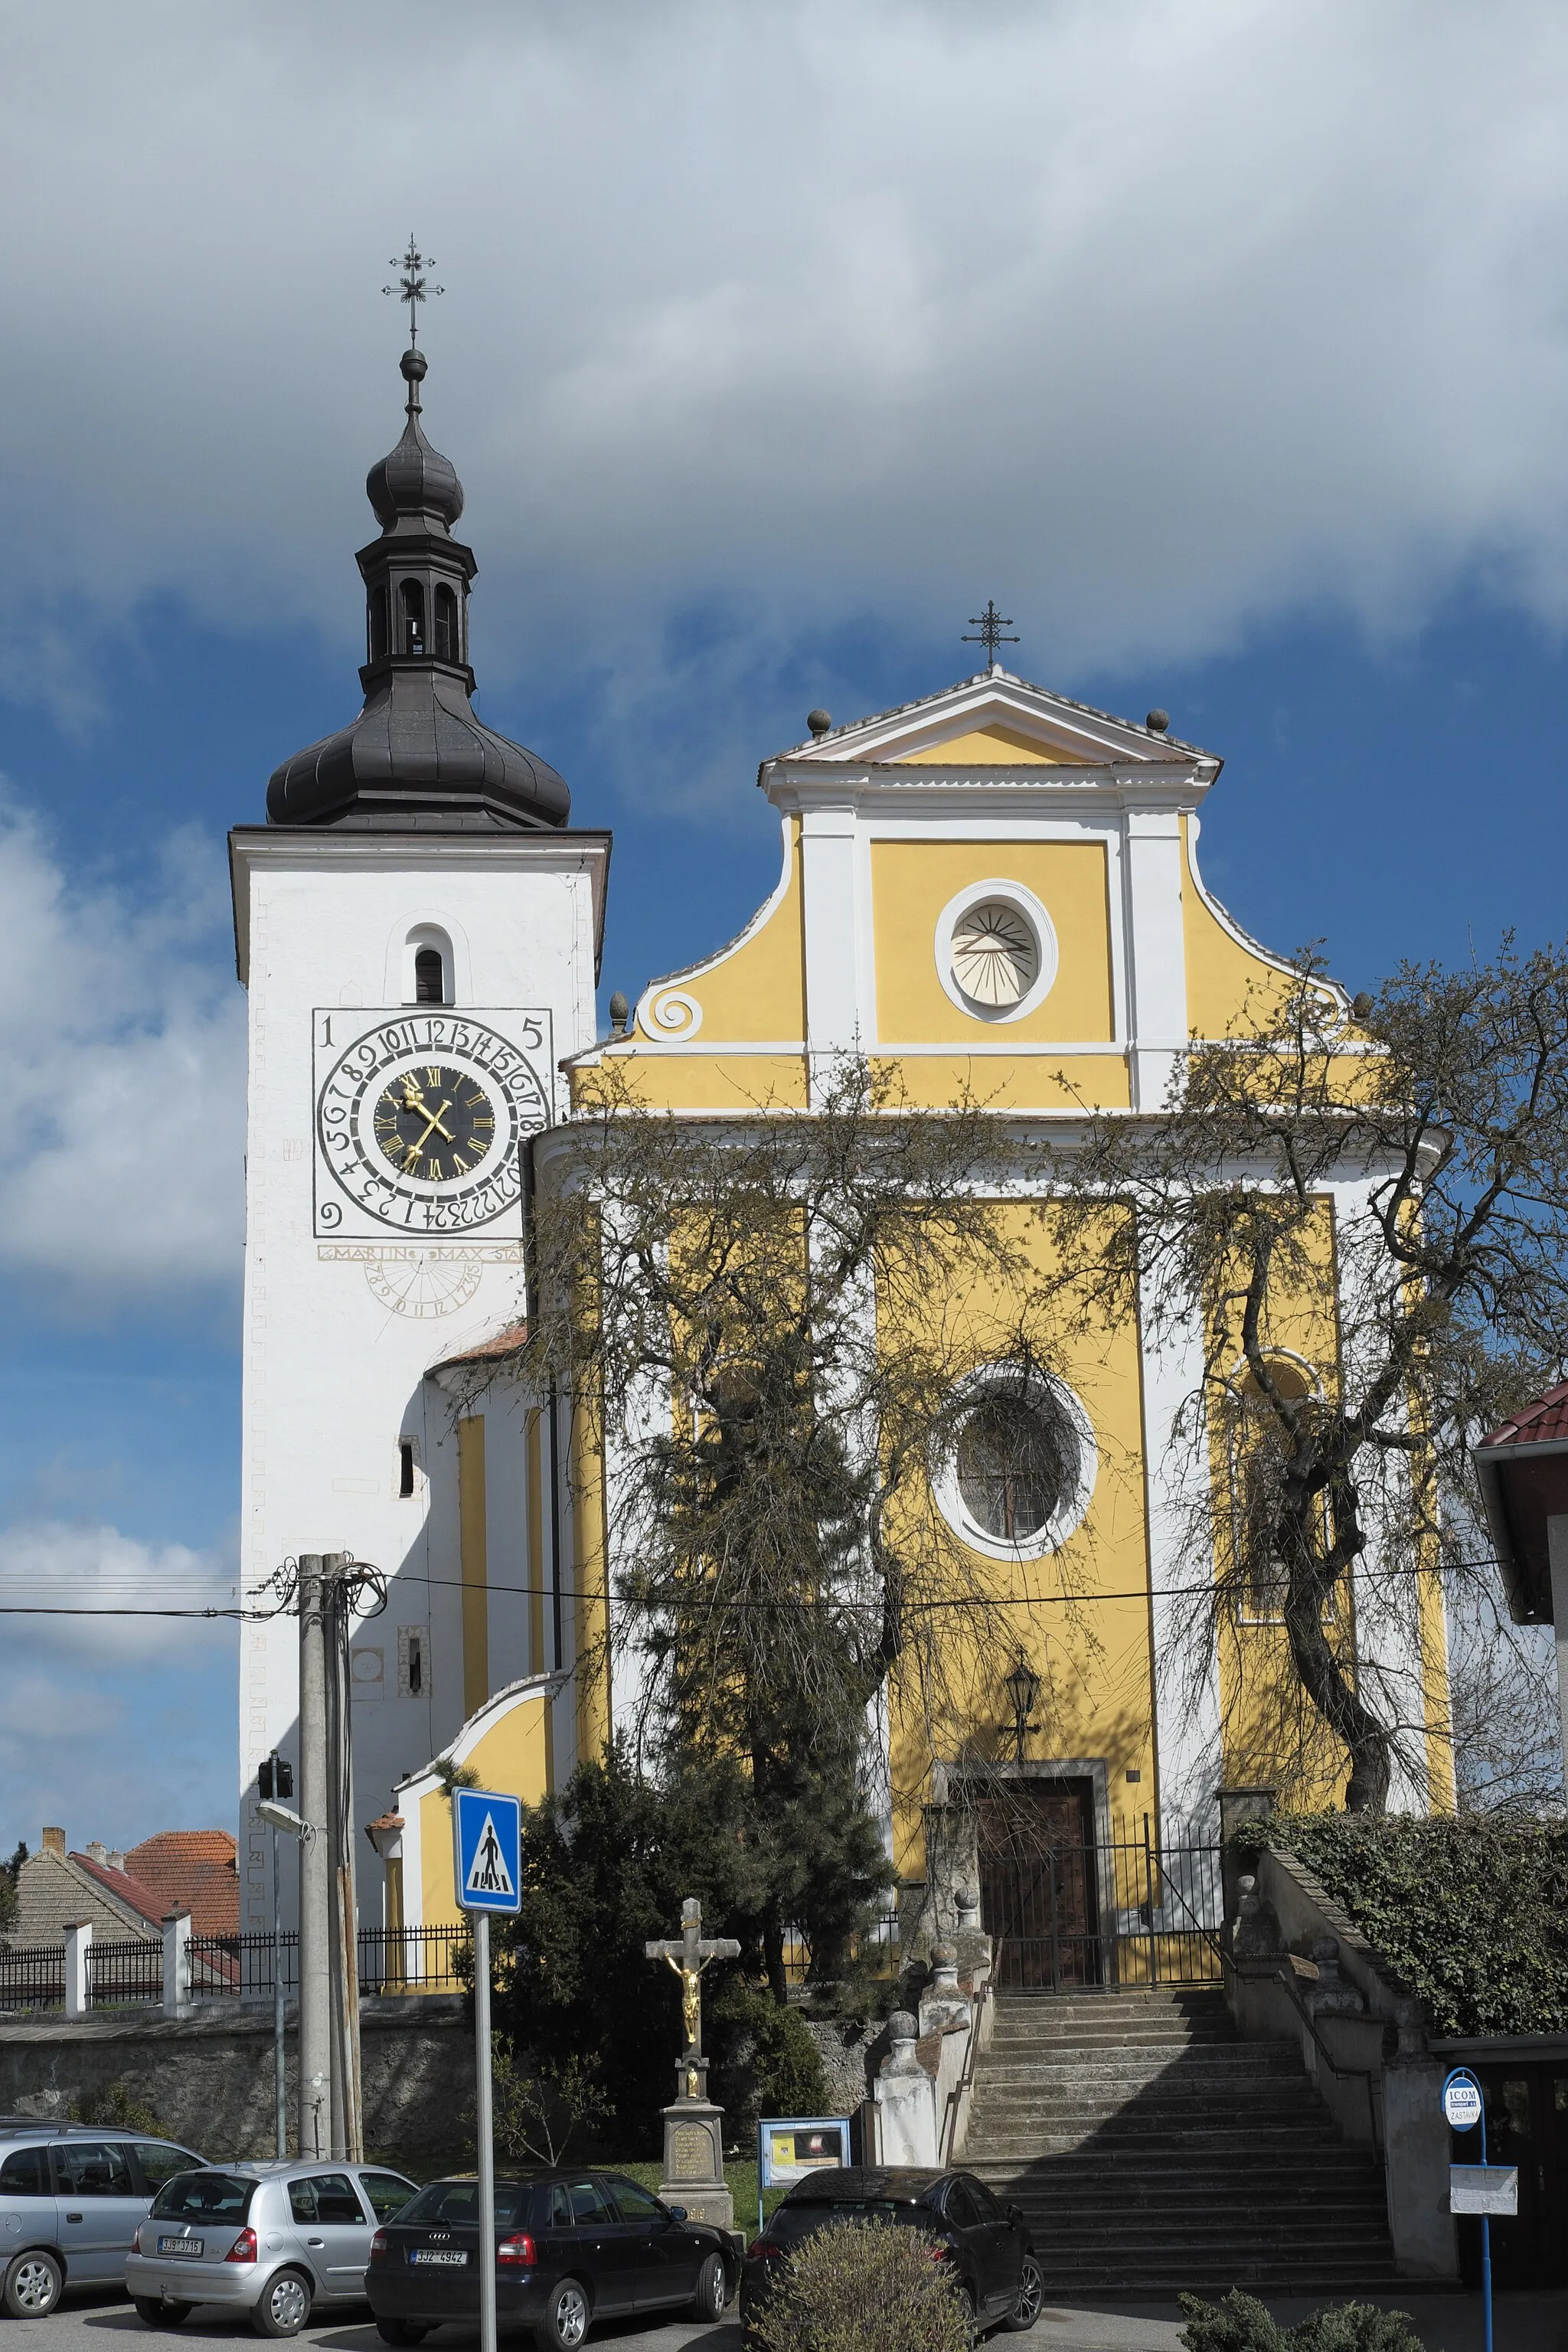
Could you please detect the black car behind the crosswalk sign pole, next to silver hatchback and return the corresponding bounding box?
[364,2166,736,2352]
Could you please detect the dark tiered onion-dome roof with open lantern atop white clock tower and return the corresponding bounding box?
[266,351,571,832]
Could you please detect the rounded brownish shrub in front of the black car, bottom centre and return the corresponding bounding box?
[753,2220,969,2352]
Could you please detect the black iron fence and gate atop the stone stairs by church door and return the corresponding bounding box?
[980,1818,1225,1992]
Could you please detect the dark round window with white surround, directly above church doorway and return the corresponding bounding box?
[936,1364,1098,1560]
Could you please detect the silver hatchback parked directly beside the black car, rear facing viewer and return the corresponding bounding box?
[125,2157,413,2335]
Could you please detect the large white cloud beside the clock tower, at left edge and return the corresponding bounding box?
[0,797,244,1315]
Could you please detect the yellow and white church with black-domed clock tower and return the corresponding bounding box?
[230,348,1453,1966]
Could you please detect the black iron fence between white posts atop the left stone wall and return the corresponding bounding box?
[0,1922,472,2011]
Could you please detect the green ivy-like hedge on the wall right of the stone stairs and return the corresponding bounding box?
[1236,1814,1568,2034]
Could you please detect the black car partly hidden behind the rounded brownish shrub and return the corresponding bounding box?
[740,2164,1041,2331]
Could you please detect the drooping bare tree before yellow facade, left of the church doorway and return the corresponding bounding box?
[517,1056,1090,1988]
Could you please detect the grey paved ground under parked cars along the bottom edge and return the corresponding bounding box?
[0,2293,1568,2352]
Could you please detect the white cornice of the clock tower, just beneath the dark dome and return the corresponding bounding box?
[228,825,611,988]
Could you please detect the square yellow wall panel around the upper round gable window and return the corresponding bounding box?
[872,842,1116,1047]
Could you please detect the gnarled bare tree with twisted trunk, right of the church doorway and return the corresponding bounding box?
[1046,943,1568,1811]
